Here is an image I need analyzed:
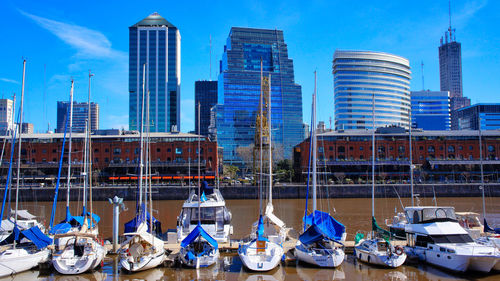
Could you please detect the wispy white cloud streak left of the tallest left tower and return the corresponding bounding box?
[19,10,127,60]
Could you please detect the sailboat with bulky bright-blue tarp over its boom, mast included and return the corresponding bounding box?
[295,72,346,267]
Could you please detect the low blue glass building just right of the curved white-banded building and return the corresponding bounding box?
[411,91,451,131]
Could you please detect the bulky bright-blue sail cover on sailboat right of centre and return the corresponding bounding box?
[299,210,345,244]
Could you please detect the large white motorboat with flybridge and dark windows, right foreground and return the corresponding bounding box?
[405,206,500,272]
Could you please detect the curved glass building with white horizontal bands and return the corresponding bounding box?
[333,50,411,130]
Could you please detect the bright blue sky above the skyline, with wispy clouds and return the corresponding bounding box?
[0,0,500,132]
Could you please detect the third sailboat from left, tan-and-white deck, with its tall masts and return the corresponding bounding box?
[120,64,165,272]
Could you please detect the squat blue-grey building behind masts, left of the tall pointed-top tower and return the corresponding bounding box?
[56,101,99,133]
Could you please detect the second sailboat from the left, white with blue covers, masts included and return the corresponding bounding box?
[52,73,107,275]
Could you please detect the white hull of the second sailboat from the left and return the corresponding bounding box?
[52,241,107,275]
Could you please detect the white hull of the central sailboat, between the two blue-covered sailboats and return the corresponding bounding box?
[238,240,284,271]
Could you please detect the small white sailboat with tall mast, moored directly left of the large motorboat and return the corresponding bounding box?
[354,95,406,268]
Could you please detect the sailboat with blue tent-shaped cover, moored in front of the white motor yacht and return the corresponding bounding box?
[179,104,220,268]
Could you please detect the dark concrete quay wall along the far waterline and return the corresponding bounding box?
[13,184,500,201]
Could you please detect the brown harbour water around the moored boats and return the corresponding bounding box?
[5,198,500,280]
